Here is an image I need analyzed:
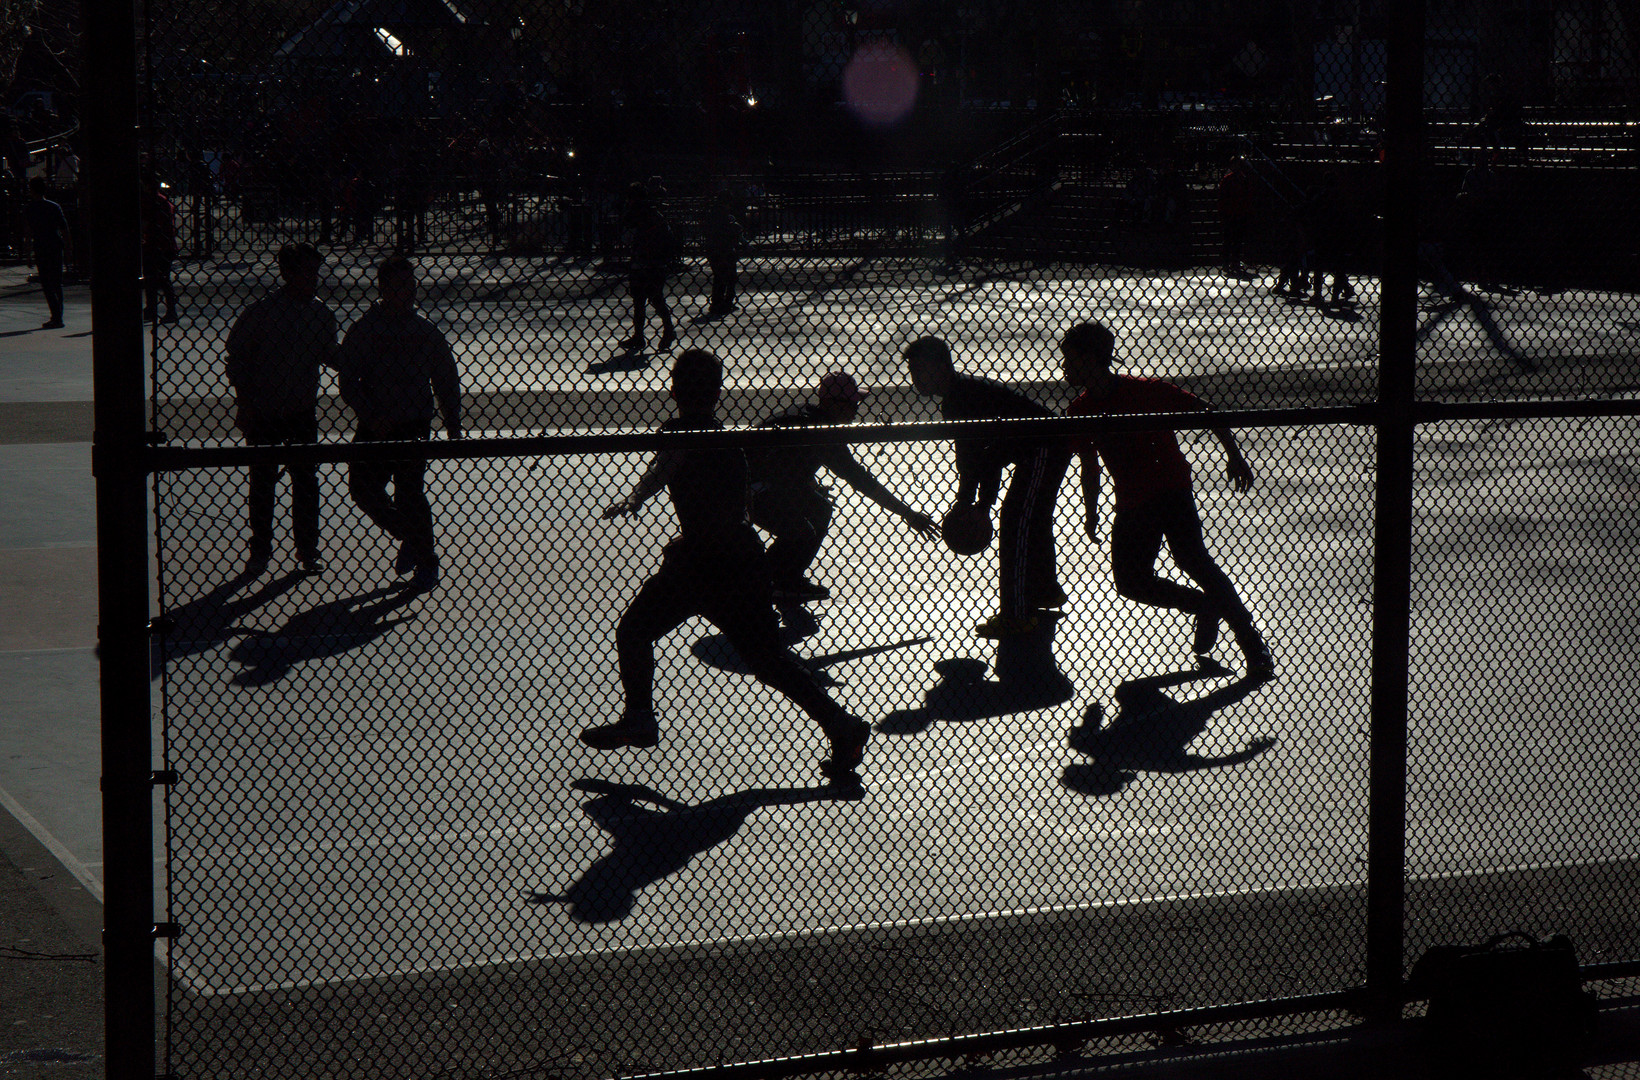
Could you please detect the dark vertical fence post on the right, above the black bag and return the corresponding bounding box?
[1366,0,1424,1021]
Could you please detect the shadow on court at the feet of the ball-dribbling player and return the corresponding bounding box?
[877,615,1076,734]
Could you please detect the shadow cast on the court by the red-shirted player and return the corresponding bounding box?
[1061,667,1276,795]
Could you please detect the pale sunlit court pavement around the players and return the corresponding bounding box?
[0,257,1640,1075]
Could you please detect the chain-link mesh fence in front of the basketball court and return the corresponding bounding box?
[77,0,1640,1077]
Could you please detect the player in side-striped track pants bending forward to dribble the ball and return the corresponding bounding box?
[905,338,1071,638]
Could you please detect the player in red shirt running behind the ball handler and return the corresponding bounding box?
[1059,323,1276,682]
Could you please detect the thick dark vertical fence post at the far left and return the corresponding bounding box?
[80,0,156,1080]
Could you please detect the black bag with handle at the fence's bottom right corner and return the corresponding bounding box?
[1407,933,1597,1080]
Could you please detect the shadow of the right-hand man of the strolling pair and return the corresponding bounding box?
[228,585,421,687]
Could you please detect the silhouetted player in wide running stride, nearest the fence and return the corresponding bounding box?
[581,349,871,783]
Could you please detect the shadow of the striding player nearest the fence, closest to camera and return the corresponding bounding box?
[530,778,858,923]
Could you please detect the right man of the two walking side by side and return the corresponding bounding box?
[339,256,461,588]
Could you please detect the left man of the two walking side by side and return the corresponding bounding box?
[226,244,336,574]
